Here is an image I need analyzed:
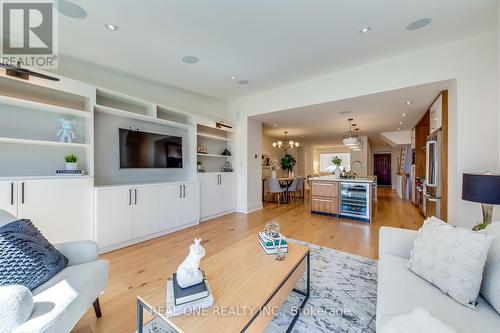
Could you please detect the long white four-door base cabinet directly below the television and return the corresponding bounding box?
[94,182,200,252]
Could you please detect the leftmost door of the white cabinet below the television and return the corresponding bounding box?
[95,188,132,248]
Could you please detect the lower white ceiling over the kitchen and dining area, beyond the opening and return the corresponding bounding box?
[252,81,453,147]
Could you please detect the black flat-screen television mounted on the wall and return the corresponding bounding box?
[119,128,182,169]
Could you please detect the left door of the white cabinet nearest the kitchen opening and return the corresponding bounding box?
[199,173,222,218]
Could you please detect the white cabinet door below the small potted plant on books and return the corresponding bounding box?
[18,178,93,243]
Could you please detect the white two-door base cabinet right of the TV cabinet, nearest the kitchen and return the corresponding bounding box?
[198,172,236,220]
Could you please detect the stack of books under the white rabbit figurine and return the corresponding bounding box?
[167,273,214,317]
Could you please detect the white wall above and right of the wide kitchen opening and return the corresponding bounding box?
[231,30,500,226]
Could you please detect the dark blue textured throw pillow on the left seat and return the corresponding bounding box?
[0,219,68,290]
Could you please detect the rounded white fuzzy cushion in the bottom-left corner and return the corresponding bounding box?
[0,285,33,332]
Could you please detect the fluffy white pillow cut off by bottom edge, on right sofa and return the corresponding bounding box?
[380,308,457,333]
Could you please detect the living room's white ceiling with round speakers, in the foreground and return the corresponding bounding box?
[59,0,497,100]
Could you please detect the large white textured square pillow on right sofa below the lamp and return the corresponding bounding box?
[408,217,494,309]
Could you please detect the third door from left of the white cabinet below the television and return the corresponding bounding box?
[159,184,183,230]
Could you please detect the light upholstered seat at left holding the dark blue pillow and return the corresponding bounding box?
[0,210,109,333]
